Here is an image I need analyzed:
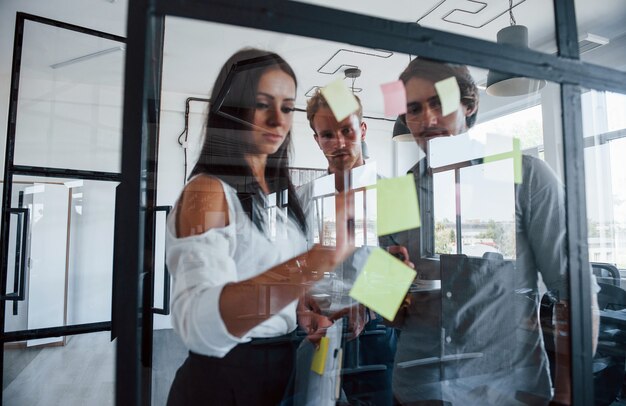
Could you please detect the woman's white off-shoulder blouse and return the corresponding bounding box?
[166,181,307,358]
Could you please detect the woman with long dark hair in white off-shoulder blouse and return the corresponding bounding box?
[166,49,350,405]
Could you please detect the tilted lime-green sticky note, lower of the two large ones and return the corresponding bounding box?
[350,248,416,320]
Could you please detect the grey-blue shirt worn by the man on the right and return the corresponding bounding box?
[393,156,597,405]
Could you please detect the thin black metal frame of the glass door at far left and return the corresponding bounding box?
[0,12,126,405]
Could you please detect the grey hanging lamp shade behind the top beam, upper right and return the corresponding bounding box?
[487,25,546,96]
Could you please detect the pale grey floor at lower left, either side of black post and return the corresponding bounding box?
[3,330,187,406]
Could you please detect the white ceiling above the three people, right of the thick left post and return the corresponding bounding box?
[163,0,626,116]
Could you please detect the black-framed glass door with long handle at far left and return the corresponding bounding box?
[0,13,125,405]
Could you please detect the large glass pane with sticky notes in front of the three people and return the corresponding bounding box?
[145,14,597,405]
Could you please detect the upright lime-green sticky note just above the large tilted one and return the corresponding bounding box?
[376,175,421,236]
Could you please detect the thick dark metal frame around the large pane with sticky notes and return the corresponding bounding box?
[116,0,626,405]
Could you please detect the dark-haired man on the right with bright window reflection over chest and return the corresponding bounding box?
[393,58,584,404]
